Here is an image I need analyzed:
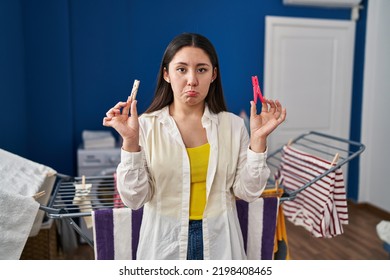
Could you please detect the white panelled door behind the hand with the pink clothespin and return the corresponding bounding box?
[259,16,355,155]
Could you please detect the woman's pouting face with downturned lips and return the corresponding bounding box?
[164,47,217,105]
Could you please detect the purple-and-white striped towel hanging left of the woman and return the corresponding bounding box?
[92,208,143,260]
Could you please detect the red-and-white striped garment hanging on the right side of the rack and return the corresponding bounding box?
[280,146,348,238]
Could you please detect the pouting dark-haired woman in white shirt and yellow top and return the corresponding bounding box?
[103,33,286,259]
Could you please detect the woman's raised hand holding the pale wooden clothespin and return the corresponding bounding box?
[103,98,140,152]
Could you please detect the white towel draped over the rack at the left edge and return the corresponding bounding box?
[0,149,56,259]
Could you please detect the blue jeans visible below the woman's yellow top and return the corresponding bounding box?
[187,220,203,260]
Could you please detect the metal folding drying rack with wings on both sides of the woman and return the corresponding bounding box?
[40,131,365,247]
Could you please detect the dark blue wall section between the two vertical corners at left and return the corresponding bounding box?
[22,0,75,174]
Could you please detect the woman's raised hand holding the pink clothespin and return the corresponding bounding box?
[250,98,286,153]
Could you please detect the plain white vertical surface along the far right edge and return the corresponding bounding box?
[359,0,390,213]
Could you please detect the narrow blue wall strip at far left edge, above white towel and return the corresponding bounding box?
[0,0,28,156]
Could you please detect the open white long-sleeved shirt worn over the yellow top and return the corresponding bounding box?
[117,107,270,259]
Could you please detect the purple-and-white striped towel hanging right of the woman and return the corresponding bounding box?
[236,197,279,260]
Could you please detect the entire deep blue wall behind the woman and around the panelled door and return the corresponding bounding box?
[0,0,367,200]
